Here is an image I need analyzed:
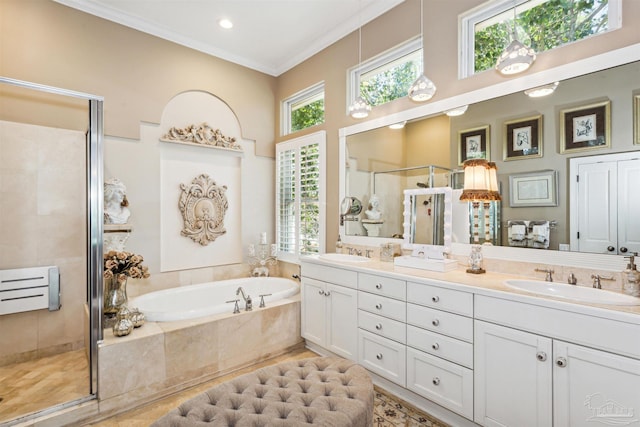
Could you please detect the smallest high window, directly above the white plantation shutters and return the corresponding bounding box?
[281,82,324,135]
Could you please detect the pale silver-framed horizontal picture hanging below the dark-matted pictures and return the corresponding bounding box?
[509,170,558,208]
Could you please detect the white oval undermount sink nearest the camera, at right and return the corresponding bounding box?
[504,280,640,305]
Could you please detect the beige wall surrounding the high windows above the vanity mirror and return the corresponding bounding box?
[275,0,640,248]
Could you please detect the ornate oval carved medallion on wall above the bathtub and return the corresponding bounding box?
[178,174,229,246]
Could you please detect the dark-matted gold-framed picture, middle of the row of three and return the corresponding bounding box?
[503,114,542,160]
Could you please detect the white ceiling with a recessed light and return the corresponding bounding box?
[54,0,404,76]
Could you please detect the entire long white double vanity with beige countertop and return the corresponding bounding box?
[302,257,640,426]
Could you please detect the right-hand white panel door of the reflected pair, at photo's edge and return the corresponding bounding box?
[618,158,640,254]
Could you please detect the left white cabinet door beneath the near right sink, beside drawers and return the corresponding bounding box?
[474,321,552,427]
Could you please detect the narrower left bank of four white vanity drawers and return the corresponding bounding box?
[358,273,406,387]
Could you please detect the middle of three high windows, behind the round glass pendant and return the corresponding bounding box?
[347,38,422,112]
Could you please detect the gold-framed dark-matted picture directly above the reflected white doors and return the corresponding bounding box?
[560,101,611,153]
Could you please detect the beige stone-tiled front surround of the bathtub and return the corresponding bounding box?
[98,294,302,420]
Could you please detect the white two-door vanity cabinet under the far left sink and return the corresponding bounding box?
[301,263,358,361]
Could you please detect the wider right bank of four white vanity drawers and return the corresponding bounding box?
[407,282,473,419]
